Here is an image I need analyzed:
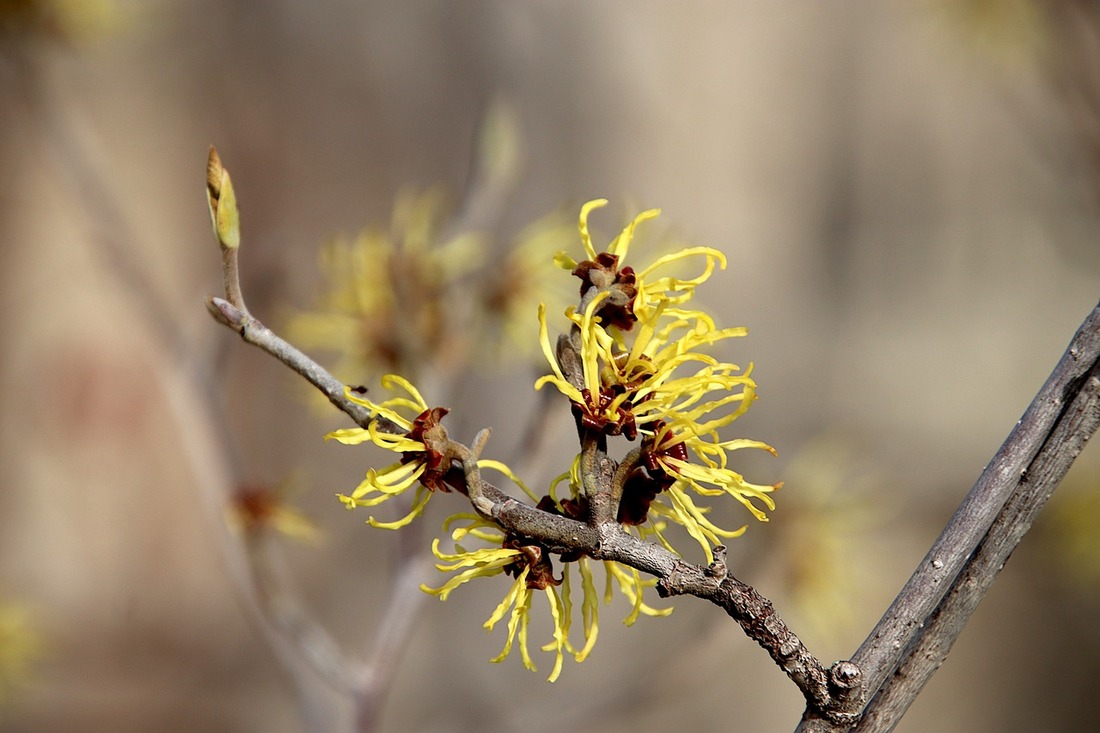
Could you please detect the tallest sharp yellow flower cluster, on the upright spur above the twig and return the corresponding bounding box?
[536,199,777,561]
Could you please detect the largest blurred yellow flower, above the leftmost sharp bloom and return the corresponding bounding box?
[288,190,483,379]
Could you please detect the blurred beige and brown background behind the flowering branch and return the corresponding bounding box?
[0,0,1100,733]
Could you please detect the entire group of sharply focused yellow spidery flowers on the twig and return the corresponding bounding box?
[327,199,780,681]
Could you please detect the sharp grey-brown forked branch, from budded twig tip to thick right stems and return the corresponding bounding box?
[200,149,1100,733]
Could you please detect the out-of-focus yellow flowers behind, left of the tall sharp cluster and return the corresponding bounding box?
[287,188,568,381]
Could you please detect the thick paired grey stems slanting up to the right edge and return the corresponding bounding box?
[798,299,1100,733]
